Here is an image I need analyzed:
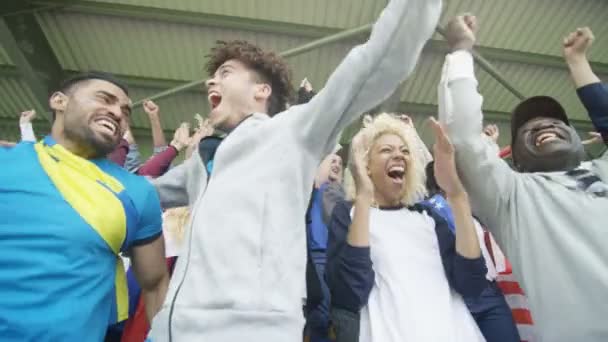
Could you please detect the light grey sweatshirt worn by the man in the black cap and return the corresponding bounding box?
[439,51,608,342]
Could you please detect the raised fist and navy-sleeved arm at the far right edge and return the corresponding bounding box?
[563,27,608,144]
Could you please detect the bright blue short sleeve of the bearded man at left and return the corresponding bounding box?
[132,183,163,245]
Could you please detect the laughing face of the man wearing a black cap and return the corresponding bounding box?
[513,117,584,172]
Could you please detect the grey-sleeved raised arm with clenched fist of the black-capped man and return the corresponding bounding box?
[439,16,516,229]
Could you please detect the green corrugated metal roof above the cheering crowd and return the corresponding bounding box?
[0,0,608,146]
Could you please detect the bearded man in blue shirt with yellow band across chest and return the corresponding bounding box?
[0,73,169,341]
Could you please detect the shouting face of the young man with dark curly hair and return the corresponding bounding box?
[206,59,271,131]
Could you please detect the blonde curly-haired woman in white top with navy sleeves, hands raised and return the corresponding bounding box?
[326,114,486,342]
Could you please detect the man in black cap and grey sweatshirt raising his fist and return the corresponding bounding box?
[439,16,608,342]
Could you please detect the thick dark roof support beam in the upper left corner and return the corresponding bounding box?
[0,13,64,121]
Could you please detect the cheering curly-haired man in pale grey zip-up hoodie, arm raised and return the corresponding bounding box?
[151,0,441,342]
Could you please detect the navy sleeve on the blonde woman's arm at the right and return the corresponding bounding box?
[427,206,488,298]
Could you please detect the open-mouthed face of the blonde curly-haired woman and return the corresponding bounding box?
[368,133,411,206]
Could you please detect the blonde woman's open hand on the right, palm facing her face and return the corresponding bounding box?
[431,118,465,197]
